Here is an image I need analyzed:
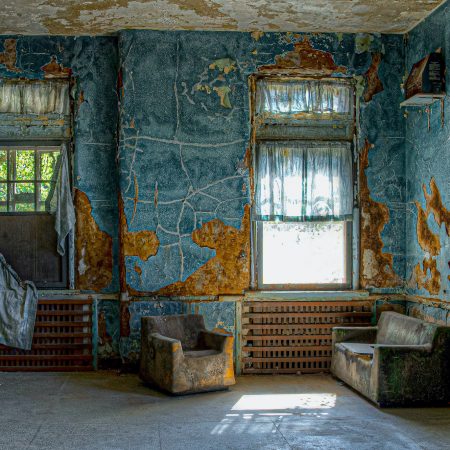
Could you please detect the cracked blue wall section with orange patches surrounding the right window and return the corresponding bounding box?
[119,31,404,296]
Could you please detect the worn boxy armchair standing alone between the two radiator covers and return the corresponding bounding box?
[140,314,235,394]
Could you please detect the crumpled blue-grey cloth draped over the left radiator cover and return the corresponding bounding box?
[0,253,38,350]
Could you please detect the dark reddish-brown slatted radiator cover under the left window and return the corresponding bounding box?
[0,299,93,372]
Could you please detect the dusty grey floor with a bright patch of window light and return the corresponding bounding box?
[0,372,450,450]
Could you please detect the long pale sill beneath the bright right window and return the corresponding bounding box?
[245,290,369,300]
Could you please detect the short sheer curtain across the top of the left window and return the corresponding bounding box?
[0,80,70,115]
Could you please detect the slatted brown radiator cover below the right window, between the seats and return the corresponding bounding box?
[242,300,372,374]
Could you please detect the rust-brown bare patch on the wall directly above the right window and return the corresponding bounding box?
[259,37,347,75]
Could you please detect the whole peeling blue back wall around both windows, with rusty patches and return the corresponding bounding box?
[0,31,405,361]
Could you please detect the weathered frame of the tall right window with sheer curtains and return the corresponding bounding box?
[249,73,359,292]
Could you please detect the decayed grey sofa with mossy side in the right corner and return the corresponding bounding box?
[331,312,450,406]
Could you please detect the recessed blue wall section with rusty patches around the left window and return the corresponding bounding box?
[0,36,118,292]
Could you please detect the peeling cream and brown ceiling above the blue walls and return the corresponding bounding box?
[0,0,444,35]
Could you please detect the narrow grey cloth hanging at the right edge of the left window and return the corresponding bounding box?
[50,143,75,255]
